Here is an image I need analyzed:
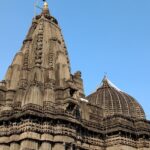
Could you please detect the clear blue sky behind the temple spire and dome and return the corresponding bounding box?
[0,0,150,119]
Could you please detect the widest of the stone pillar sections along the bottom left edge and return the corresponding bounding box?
[20,140,39,150]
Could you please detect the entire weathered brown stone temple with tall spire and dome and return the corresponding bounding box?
[0,2,150,150]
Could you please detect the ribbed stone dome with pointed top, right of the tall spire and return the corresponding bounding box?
[87,77,145,119]
